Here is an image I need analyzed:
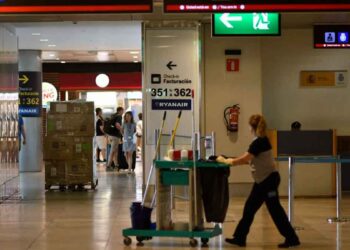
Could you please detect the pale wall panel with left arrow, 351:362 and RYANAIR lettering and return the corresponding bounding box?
[143,28,200,145]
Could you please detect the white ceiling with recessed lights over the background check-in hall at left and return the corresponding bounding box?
[12,21,142,62]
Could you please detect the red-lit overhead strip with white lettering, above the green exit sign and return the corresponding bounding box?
[164,0,350,13]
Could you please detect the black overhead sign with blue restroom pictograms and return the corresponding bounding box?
[314,25,350,49]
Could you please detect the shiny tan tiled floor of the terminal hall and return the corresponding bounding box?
[0,162,350,250]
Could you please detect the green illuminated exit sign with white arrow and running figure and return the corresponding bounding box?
[212,13,281,36]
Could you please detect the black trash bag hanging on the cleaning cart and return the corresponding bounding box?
[198,168,230,223]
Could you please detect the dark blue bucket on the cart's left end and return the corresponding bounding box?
[130,202,152,229]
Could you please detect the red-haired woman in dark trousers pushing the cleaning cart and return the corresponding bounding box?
[217,115,300,248]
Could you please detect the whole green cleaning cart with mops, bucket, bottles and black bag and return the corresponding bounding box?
[122,108,229,247]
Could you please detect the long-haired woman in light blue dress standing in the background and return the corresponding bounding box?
[122,111,136,173]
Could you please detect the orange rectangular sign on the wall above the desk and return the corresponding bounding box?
[300,70,348,87]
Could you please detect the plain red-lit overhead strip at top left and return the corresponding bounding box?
[0,0,153,14]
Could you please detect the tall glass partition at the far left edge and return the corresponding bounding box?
[0,25,19,203]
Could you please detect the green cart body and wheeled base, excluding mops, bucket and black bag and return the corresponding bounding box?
[123,161,229,247]
